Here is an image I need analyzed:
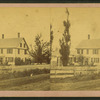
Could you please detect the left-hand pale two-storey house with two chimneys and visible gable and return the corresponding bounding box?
[0,33,29,65]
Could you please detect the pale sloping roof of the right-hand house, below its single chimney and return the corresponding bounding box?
[76,39,100,49]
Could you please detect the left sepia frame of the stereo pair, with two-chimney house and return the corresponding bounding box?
[0,7,50,91]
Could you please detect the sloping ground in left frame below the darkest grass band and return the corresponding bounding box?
[0,74,50,91]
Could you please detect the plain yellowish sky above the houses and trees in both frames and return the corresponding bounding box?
[0,7,100,53]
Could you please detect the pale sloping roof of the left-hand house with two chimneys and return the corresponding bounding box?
[0,38,28,48]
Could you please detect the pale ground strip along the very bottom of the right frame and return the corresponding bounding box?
[50,79,100,91]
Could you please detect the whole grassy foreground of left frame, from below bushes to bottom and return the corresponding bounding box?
[0,65,50,91]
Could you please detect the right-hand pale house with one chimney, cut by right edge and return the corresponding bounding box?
[76,35,100,65]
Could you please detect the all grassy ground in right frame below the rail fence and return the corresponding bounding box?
[50,72,100,91]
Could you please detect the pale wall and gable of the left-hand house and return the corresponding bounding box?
[0,40,29,65]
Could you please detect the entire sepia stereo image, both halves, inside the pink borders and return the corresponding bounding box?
[0,6,100,93]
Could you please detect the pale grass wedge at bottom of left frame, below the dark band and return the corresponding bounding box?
[6,80,50,91]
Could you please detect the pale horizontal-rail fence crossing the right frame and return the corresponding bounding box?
[50,66,100,78]
